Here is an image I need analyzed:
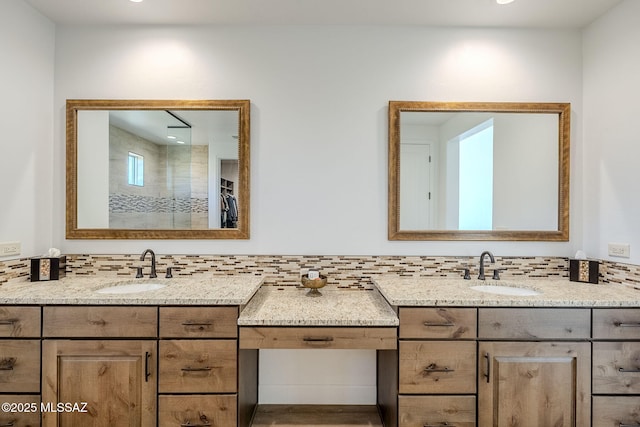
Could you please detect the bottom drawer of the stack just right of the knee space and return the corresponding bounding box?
[398,396,476,427]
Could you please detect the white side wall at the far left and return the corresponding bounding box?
[0,0,54,260]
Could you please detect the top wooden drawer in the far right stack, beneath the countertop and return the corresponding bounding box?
[593,308,640,340]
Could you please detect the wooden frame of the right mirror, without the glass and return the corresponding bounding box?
[387,101,571,242]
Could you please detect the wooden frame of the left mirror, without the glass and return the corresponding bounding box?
[65,99,251,240]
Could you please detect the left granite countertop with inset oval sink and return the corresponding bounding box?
[0,275,264,305]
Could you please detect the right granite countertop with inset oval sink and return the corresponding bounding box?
[374,276,640,307]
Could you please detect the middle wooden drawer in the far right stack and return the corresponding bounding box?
[592,342,640,394]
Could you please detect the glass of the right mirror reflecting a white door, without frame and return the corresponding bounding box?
[400,111,559,231]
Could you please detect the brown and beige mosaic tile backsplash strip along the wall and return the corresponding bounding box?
[0,255,640,289]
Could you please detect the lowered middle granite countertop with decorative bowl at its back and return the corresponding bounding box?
[238,286,398,326]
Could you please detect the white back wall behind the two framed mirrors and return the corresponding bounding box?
[54,26,582,256]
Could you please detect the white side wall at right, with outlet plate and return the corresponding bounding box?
[581,0,640,264]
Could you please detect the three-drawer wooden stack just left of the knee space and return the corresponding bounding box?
[158,307,239,427]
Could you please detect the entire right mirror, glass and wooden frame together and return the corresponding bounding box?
[388,101,571,241]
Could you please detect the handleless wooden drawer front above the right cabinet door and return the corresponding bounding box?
[478,308,591,340]
